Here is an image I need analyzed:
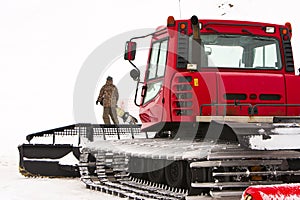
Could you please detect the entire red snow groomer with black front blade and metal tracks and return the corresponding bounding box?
[19,16,300,200]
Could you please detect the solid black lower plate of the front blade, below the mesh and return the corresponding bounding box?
[18,144,80,177]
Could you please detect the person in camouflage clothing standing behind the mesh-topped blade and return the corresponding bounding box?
[96,76,119,124]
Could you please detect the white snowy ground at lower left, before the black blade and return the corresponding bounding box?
[0,145,121,200]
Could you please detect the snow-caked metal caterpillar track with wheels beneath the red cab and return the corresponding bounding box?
[79,139,300,199]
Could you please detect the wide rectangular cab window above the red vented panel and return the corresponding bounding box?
[192,34,282,69]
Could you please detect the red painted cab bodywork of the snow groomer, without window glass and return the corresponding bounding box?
[140,20,300,130]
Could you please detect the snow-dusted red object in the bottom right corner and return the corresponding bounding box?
[242,183,300,200]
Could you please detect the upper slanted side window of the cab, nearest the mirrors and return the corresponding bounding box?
[147,40,168,80]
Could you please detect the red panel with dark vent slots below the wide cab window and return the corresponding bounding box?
[217,72,286,116]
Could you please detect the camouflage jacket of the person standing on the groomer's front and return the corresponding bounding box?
[98,81,119,107]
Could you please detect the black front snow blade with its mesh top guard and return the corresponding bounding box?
[18,123,143,177]
